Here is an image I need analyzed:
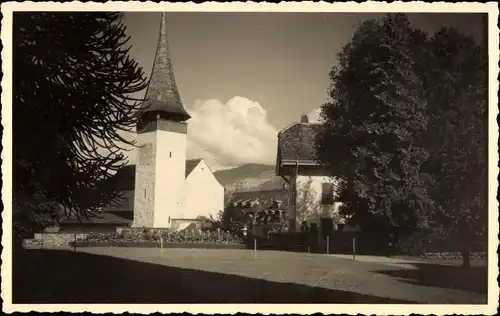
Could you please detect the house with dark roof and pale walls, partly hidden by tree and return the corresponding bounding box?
[276,115,358,236]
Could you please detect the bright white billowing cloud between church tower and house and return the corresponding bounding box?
[119,96,277,170]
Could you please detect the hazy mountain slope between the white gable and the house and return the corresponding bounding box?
[214,164,284,192]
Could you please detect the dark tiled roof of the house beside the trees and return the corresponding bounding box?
[278,123,321,163]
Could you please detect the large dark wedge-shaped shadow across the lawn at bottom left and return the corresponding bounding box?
[12,250,412,304]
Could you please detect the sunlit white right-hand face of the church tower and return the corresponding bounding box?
[154,130,187,227]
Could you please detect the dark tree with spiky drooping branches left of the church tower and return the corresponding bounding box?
[13,12,147,230]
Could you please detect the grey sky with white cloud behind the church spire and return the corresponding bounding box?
[124,12,483,170]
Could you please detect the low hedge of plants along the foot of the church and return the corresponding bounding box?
[82,228,243,244]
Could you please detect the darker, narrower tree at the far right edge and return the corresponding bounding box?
[423,28,488,266]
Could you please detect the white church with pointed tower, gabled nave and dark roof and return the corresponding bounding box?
[61,12,224,229]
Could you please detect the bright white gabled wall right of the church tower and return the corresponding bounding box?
[184,160,224,219]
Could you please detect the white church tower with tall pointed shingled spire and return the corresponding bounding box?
[133,12,191,228]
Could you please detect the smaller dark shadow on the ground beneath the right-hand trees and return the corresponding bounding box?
[372,263,488,294]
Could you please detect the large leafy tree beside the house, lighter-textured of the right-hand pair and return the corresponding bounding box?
[316,14,431,252]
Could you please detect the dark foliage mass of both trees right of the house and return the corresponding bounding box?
[316,14,487,260]
